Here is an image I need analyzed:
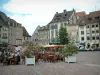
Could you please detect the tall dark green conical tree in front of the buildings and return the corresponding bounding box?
[59,26,69,45]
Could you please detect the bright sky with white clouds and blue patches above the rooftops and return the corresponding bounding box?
[0,0,100,35]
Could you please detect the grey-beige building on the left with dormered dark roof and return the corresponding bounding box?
[8,18,23,45]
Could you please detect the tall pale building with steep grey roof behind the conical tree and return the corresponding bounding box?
[48,9,78,43]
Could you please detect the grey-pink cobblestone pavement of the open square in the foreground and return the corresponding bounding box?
[0,52,100,75]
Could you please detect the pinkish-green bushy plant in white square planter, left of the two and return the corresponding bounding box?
[23,41,38,65]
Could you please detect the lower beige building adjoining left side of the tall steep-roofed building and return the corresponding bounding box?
[38,25,49,45]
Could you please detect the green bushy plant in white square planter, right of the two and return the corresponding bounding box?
[61,44,78,63]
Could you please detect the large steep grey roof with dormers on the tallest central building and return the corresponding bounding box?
[49,10,75,24]
